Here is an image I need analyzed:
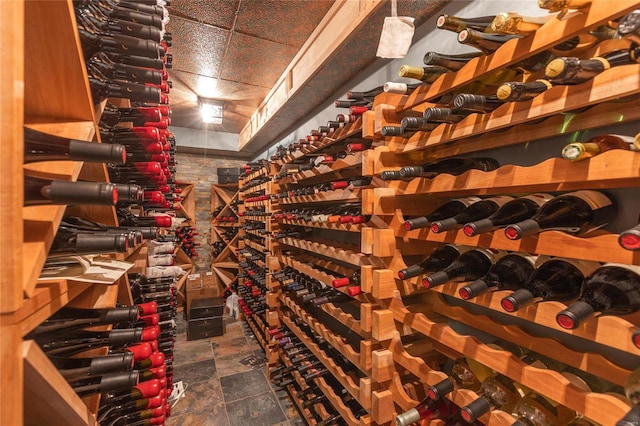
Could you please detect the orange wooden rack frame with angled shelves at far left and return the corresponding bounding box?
[0,0,172,425]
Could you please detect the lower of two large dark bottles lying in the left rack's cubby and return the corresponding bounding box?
[24,175,118,206]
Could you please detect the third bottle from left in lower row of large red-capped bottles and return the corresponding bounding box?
[458,253,537,300]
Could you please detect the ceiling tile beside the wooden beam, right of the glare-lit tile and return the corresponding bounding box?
[220,33,298,88]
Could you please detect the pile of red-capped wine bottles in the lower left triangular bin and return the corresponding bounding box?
[27,274,177,425]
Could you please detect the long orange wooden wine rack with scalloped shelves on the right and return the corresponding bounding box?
[236,0,640,426]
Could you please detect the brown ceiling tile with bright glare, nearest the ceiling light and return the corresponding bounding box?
[168,19,230,77]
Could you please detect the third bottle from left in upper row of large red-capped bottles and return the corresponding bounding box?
[462,193,553,237]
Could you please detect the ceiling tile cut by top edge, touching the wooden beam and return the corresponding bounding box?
[235,0,335,48]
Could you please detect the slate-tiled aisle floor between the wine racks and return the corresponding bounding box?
[167,312,304,426]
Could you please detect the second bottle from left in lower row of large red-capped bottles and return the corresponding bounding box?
[422,248,505,288]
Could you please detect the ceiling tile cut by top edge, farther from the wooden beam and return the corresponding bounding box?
[169,0,239,30]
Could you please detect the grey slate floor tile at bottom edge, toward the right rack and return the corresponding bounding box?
[227,392,288,426]
